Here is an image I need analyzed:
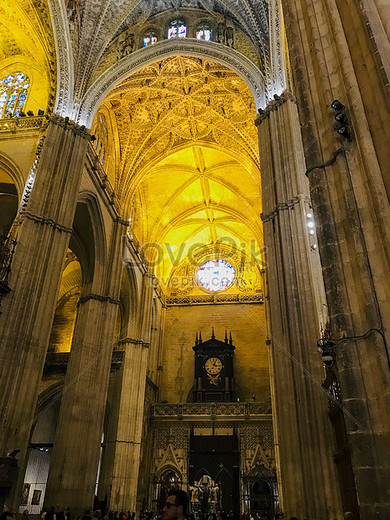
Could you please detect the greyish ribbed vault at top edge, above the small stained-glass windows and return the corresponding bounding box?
[67,0,268,102]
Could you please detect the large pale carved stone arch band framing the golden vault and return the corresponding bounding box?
[77,38,266,127]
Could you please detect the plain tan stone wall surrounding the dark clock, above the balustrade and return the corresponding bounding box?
[160,304,270,402]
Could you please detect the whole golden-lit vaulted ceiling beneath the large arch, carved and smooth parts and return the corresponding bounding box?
[96,56,262,294]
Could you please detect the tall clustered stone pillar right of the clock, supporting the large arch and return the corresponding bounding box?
[256,93,341,520]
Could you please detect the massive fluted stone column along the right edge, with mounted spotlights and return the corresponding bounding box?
[282,0,390,520]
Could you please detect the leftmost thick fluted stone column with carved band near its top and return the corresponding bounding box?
[0,116,89,508]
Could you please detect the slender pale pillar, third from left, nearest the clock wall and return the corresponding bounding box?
[107,273,154,511]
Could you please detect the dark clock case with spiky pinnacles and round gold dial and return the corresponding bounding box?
[192,329,236,403]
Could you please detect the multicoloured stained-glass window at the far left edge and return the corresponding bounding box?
[0,72,30,117]
